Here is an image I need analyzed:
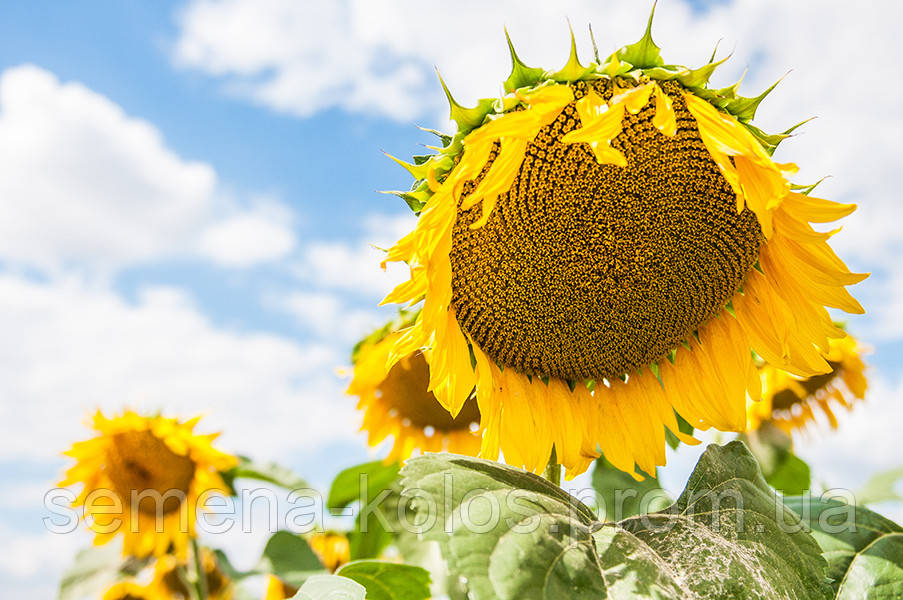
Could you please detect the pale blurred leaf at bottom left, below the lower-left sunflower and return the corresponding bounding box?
[58,544,149,600]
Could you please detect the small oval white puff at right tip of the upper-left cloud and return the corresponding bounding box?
[198,203,297,267]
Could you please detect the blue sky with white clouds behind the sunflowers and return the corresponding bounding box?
[0,0,903,598]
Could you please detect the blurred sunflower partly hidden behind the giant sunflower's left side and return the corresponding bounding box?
[348,315,480,461]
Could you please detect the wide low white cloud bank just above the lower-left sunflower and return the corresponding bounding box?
[0,275,358,460]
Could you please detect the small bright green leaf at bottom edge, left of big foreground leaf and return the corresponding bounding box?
[336,560,430,600]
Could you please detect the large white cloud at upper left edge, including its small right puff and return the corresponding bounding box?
[0,65,295,273]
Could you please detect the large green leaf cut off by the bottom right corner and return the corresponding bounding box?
[785,496,903,600]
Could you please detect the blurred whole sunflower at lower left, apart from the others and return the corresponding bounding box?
[60,411,237,560]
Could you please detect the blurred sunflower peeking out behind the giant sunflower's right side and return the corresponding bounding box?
[749,335,868,434]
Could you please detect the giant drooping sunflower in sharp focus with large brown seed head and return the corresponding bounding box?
[384,11,866,476]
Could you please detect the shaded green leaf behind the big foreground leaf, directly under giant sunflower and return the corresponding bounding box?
[593,456,671,521]
